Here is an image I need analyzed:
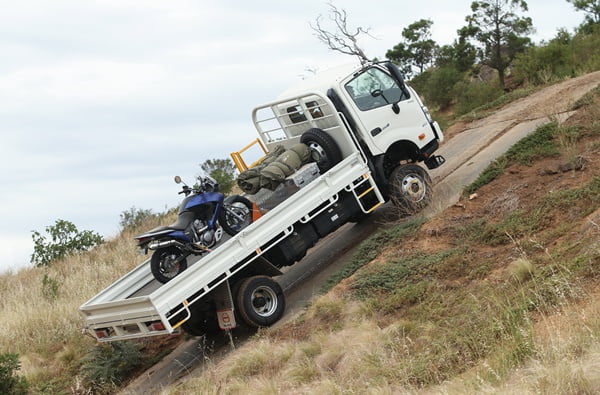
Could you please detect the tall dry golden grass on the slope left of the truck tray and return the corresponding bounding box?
[0,212,172,385]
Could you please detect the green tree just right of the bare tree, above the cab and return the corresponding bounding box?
[385,19,438,75]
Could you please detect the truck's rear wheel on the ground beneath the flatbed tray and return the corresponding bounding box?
[235,276,285,328]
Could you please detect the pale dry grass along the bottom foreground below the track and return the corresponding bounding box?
[168,284,600,394]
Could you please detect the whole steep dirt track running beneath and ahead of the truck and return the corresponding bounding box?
[123,72,600,394]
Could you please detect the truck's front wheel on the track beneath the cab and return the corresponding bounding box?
[389,163,432,216]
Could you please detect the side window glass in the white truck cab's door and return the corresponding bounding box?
[345,67,407,111]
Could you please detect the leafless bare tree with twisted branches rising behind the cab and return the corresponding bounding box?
[310,3,373,64]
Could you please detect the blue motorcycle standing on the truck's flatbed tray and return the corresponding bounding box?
[135,174,252,283]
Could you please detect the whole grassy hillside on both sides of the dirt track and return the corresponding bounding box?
[0,76,600,393]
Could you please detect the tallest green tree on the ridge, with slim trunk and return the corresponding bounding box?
[465,0,533,88]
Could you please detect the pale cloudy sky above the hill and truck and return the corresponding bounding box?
[0,0,584,273]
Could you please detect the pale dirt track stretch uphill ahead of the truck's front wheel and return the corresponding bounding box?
[427,72,600,215]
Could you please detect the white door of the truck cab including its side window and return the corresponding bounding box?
[344,66,433,155]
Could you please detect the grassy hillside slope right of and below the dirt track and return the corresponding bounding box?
[168,83,600,393]
